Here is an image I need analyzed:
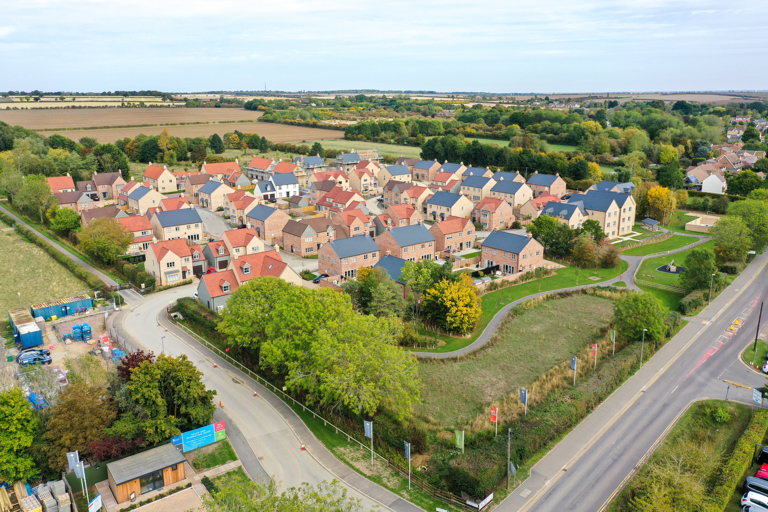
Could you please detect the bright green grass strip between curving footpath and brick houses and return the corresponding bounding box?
[413,261,627,353]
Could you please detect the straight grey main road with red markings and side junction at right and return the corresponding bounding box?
[498,254,768,512]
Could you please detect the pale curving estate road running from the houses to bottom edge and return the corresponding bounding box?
[113,286,421,512]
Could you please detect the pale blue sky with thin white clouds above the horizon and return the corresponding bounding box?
[0,0,768,93]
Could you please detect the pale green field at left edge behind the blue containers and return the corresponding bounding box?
[0,231,88,314]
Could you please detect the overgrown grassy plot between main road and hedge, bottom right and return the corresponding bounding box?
[608,400,751,512]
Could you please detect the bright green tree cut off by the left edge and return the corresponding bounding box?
[0,388,39,482]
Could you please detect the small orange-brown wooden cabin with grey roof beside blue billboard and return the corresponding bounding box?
[107,444,186,503]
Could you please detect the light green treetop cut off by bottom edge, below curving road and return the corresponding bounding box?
[203,473,363,512]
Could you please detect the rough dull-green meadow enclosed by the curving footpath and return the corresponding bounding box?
[415,294,613,428]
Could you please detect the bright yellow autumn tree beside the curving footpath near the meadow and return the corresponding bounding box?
[422,274,482,334]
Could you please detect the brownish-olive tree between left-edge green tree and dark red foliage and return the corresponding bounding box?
[44,383,117,471]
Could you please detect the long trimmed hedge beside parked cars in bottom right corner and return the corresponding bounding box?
[711,410,768,510]
